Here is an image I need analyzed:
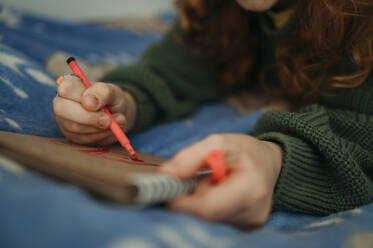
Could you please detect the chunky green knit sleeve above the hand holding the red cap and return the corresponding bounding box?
[254,80,373,215]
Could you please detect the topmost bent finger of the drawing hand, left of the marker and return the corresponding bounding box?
[57,76,85,102]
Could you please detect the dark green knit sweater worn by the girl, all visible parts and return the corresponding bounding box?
[102,15,373,215]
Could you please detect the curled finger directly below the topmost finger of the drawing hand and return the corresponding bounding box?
[53,96,111,129]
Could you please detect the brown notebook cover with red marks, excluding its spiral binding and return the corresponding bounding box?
[0,131,165,203]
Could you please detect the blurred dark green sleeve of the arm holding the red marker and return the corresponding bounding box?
[101,23,221,131]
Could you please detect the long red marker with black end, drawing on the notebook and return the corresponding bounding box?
[66,57,138,160]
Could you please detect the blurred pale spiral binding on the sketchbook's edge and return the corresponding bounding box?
[131,170,210,205]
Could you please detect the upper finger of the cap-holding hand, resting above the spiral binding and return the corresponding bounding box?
[160,135,222,179]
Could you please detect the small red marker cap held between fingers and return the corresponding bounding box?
[206,149,227,183]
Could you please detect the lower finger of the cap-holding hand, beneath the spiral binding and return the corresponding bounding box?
[170,173,247,221]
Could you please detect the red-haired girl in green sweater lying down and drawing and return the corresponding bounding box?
[54,0,373,227]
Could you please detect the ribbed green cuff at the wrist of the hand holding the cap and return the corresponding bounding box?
[257,132,339,215]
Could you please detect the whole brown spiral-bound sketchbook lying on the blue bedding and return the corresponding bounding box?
[0,131,204,205]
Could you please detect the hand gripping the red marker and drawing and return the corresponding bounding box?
[53,76,136,145]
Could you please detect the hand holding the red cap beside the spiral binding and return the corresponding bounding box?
[160,134,282,227]
